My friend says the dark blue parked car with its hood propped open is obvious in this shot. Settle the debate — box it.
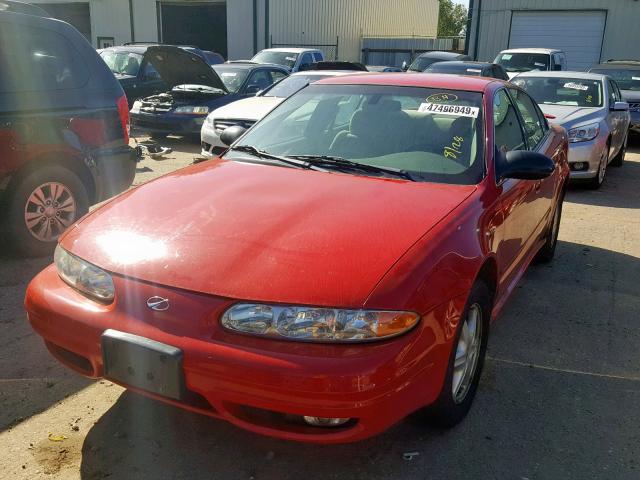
[131,46,289,141]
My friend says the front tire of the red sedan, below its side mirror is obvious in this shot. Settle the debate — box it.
[426,281,492,428]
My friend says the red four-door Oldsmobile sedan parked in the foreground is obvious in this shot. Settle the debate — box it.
[26,74,569,443]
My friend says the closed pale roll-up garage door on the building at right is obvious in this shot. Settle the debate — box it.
[509,10,607,71]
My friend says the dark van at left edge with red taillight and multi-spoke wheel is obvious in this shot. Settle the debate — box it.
[0,5,136,255]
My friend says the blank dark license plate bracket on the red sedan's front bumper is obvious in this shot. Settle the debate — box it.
[101,330,184,400]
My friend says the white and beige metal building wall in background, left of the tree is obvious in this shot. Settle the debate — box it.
[37,0,438,61]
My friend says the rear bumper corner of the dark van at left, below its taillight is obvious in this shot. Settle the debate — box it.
[92,145,137,203]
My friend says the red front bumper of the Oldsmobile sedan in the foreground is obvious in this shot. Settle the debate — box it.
[25,266,456,443]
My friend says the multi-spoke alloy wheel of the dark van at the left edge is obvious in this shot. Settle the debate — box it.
[24,182,77,242]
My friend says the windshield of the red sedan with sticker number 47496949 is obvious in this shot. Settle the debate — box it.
[225,84,484,185]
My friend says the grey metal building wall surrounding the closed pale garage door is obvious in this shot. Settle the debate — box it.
[469,0,640,61]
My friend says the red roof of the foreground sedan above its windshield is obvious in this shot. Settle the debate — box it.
[316,73,500,92]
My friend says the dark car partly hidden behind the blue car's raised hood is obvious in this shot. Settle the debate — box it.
[99,43,224,107]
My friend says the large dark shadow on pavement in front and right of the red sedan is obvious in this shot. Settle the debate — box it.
[81,242,640,480]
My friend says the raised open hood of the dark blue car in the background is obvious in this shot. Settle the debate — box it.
[144,45,228,92]
